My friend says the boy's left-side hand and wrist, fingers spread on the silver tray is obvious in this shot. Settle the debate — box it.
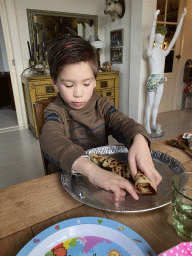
[73,157,139,201]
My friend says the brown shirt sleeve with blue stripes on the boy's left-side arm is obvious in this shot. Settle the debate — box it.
[39,105,86,172]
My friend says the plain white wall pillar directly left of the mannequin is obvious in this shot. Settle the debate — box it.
[129,0,156,123]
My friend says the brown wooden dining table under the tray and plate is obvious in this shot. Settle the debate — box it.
[0,135,192,256]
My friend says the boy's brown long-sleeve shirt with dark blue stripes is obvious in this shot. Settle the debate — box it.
[39,91,149,171]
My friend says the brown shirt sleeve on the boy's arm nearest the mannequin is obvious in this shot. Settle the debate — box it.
[100,98,151,149]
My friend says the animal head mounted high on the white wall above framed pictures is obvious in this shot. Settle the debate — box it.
[104,0,125,22]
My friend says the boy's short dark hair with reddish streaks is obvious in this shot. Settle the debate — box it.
[47,35,99,82]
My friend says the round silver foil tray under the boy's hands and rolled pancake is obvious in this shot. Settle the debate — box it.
[61,145,185,213]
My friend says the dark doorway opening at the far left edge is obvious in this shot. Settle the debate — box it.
[0,17,18,130]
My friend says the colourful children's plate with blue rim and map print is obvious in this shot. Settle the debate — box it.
[17,217,157,256]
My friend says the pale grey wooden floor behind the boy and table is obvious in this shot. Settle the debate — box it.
[0,108,192,189]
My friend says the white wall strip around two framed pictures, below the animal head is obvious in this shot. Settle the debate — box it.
[103,0,131,114]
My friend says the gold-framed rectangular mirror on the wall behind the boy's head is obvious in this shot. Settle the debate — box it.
[27,9,98,63]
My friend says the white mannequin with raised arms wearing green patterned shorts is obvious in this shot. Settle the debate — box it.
[145,8,187,134]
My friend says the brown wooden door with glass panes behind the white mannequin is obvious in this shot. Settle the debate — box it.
[157,0,183,112]
